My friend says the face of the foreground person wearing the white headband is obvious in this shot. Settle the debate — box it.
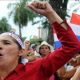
[0,35,20,66]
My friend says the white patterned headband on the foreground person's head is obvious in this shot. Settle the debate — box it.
[2,32,24,48]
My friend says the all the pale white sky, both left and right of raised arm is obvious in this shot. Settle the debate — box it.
[0,0,80,39]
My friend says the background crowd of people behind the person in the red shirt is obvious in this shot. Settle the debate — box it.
[22,39,80,80]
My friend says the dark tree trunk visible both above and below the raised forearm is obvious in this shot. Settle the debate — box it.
[36,0,68,45]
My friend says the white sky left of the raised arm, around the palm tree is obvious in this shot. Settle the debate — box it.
[0,0,40,39]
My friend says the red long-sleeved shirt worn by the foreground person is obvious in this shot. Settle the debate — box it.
[5,22,80,80]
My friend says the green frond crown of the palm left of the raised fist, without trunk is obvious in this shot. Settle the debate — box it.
[14,0,36,27]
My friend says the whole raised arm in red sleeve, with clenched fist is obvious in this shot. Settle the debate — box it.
[28,1,80,74]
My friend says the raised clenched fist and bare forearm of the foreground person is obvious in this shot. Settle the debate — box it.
[28,1,67,29]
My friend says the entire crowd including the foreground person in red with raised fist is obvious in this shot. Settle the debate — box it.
[0,1,80,80]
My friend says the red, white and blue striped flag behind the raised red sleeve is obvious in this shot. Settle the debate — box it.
[54,13,80,49]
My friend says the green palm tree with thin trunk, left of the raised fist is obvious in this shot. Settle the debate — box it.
[8,0,37,37]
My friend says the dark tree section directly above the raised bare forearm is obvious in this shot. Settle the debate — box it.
[49,0,68,19]
